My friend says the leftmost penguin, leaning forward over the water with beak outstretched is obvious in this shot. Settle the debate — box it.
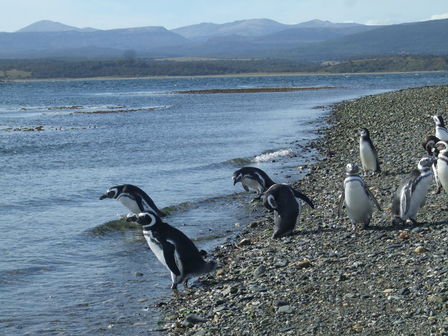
[100,184,166,217]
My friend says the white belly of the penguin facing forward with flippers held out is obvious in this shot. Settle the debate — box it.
[345,182,372,222]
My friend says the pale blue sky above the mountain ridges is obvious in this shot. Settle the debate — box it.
[0,0,448,32]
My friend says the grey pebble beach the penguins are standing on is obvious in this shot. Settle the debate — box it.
[159,86,448,336]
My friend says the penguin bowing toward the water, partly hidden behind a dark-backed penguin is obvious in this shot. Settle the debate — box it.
[232,167,275,200]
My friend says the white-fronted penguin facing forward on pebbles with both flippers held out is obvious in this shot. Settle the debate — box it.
[338,163,382,230]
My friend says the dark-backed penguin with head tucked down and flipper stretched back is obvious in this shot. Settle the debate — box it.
[263,184,314,238]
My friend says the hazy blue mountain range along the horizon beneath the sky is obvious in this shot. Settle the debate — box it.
[0,19,448,62]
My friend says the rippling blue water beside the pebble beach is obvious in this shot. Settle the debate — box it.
[0,73,448,335]
